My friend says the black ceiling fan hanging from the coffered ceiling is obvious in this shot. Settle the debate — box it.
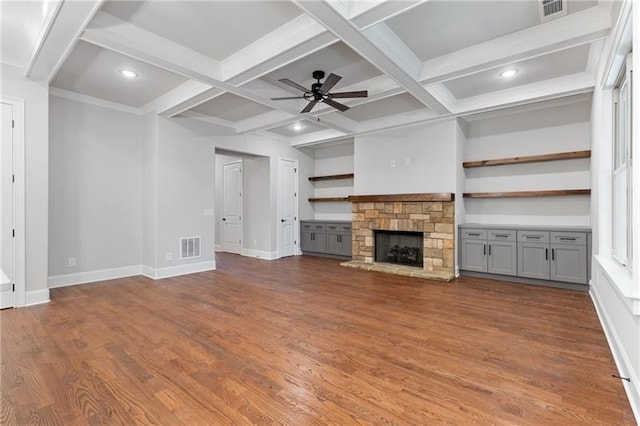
[271,71,368,112]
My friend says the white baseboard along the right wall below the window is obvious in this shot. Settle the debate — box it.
[589,286,640,423]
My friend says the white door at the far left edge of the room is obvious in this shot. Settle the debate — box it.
[0,103,15,309]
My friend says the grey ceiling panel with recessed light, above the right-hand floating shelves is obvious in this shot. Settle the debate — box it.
[444,45,589,99]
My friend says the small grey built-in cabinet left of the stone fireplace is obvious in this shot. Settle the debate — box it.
[300,220,351,259]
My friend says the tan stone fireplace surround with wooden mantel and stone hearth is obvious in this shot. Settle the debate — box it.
[342,193,455,281]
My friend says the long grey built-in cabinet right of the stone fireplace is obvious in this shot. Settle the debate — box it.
[459,225,591,284]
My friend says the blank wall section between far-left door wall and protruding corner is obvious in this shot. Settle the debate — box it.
[49,96,144,276]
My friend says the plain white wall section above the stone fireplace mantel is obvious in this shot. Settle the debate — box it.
[354,119,456,195]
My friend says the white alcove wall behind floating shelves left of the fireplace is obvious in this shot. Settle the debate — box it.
[312,139,354,221]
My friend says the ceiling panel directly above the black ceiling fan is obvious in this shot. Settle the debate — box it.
[262,42,382,96]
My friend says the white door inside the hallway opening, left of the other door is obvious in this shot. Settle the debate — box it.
[222,160,243,254]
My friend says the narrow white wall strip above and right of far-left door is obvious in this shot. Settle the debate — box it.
[0,64,49,305]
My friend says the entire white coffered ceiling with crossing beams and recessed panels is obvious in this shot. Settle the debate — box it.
[0,0,619,146]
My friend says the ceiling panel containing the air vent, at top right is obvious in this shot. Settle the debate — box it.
[387,0,597,61]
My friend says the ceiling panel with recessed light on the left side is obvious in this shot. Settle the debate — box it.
[51,41,186,107]
